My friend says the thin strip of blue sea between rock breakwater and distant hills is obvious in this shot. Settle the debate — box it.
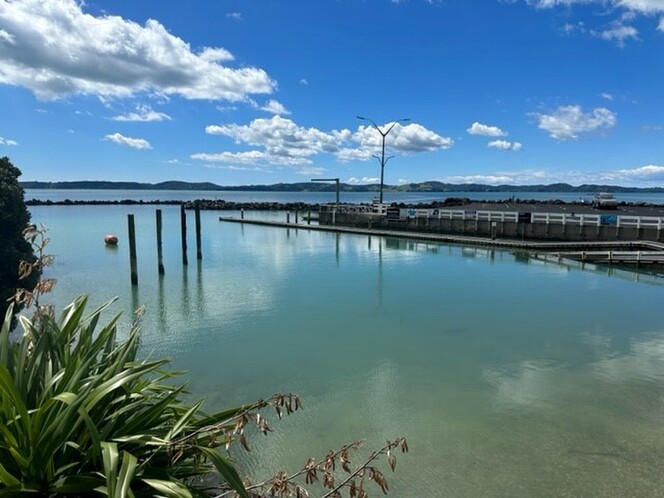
[25,189,664,204]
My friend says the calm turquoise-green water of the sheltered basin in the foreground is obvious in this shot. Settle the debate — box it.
[28,204,664,497]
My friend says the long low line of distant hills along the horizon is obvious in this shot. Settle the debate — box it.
[21,181,664,194]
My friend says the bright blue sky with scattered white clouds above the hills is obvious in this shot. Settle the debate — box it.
[0,0,664,187]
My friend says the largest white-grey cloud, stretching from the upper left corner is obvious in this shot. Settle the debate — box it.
[0,0,275,101]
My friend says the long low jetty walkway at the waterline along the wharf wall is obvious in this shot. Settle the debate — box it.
[219,216,664,266]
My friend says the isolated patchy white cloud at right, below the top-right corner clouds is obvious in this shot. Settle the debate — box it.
[535,105,616,140]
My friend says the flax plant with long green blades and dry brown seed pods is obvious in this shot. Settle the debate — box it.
[0,227,408,498]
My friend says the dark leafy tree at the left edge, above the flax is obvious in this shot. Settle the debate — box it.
[0,157,39,317]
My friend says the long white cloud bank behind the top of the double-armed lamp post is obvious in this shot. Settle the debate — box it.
[191,115,453,171]
